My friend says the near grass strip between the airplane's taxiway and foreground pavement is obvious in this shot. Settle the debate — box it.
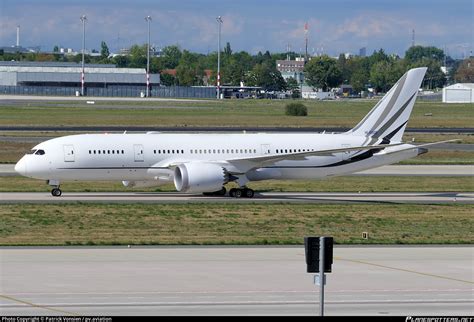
[0,202,474,245]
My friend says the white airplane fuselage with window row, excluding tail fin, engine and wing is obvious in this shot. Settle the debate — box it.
[17,133,418,184]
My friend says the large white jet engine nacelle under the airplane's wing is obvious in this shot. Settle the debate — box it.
[174,162,229,193]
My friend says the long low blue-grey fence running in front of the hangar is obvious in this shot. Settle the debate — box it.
[0,85,216,98]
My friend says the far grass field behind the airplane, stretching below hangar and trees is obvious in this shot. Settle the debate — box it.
[0,100,474,130]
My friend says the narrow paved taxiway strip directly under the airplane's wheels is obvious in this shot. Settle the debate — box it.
[0,191,474,204]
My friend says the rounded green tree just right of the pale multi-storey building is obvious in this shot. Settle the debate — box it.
[304,55,342,91]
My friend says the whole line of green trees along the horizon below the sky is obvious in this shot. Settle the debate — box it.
[0,41,474,93]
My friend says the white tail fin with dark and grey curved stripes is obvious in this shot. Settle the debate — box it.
[348,67,427,145]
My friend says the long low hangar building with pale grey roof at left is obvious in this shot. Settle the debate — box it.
[0,61,160,97]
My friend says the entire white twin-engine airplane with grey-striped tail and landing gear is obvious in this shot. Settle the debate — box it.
[15,67,448,198]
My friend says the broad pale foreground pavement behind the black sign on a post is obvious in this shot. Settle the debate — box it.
[0,247,474,316]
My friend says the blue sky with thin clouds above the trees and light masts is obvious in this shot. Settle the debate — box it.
[0,0,474,58]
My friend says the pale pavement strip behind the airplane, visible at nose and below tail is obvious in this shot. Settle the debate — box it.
[0,164,474,176]
